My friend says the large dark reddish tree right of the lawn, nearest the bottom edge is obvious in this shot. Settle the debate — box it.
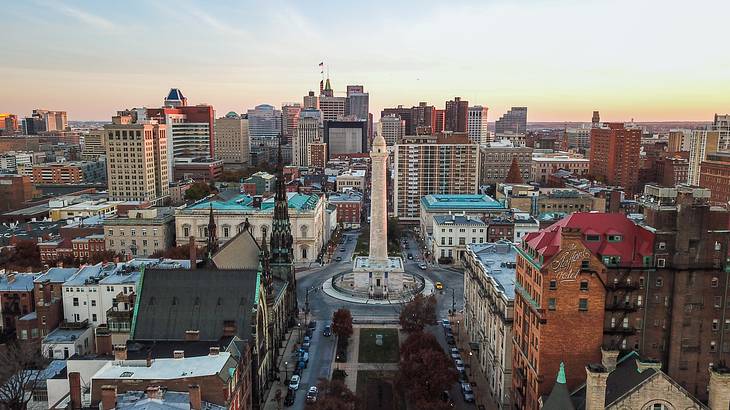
[396,332,457,408]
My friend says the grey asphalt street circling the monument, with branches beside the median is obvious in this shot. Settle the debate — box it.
[290,230,466,409]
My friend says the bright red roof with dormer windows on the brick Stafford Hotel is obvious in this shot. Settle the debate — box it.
[525,212,654,266]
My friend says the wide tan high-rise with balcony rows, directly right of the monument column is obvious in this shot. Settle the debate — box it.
[393,134,479,222]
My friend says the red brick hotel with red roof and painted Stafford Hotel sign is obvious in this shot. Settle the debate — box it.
[512,213,653,409]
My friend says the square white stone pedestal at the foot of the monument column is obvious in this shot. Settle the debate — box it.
[352,256,408,299]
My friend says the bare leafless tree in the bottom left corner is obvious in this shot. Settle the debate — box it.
[0,342,48,410]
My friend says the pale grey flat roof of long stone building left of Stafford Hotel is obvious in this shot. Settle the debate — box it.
[467,241,517,300]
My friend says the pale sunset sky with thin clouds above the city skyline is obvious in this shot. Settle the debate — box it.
[0,0,730,122]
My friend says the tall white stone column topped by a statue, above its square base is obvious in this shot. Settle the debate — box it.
[369,135,388,266]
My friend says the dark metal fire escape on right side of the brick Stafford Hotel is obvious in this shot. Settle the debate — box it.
[603,269,639,350]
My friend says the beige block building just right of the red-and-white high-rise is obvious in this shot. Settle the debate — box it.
[215,112,251,168]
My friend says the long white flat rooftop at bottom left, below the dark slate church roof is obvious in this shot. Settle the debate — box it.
[92,352,235,380]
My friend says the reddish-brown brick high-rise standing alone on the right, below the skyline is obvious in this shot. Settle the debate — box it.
[589,123,641,193]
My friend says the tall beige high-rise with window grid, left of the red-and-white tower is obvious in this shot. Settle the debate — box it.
[104,117,170,204]
